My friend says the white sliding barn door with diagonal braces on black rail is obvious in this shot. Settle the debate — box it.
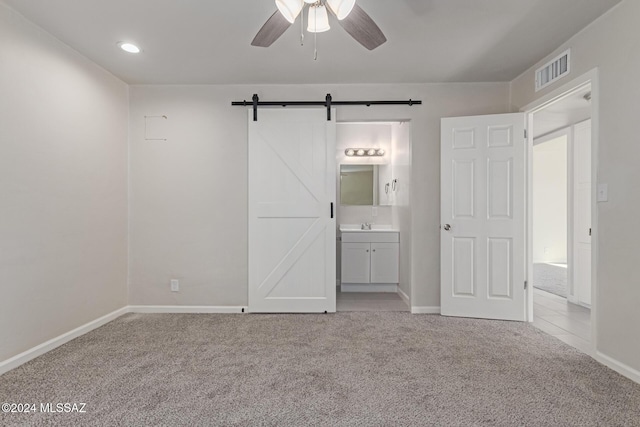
[248,108,336,313]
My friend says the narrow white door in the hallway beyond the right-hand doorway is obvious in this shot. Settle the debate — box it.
[573,120,591,306]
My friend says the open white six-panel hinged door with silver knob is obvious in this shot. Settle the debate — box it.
[440,113,525,321]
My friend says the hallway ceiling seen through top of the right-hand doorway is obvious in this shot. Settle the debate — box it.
[533,86,591,138]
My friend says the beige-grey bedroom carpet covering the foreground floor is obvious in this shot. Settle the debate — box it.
[0,312,640,426]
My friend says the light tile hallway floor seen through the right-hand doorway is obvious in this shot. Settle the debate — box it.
[533,289,591,354]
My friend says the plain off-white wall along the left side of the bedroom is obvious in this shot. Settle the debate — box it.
[0,3,128,361]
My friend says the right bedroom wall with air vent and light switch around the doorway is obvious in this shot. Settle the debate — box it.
[511,0,640,371]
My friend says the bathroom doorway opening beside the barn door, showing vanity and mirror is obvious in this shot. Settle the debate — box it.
[336,121,411,312]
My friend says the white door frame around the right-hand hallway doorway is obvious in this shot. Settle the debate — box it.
[520,68,600,356]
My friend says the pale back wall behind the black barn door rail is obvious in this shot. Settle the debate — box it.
[130,83,508,306]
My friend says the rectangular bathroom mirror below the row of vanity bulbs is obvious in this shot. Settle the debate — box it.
[340,165,391,206]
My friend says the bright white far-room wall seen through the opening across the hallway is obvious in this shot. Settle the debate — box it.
[533,135,568,263]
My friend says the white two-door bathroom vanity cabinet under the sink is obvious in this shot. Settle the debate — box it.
[340,230,400,292]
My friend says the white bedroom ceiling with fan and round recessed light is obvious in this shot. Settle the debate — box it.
[0,0,620,84]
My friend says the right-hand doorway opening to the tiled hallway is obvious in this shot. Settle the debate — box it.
[528,80,594,353]
